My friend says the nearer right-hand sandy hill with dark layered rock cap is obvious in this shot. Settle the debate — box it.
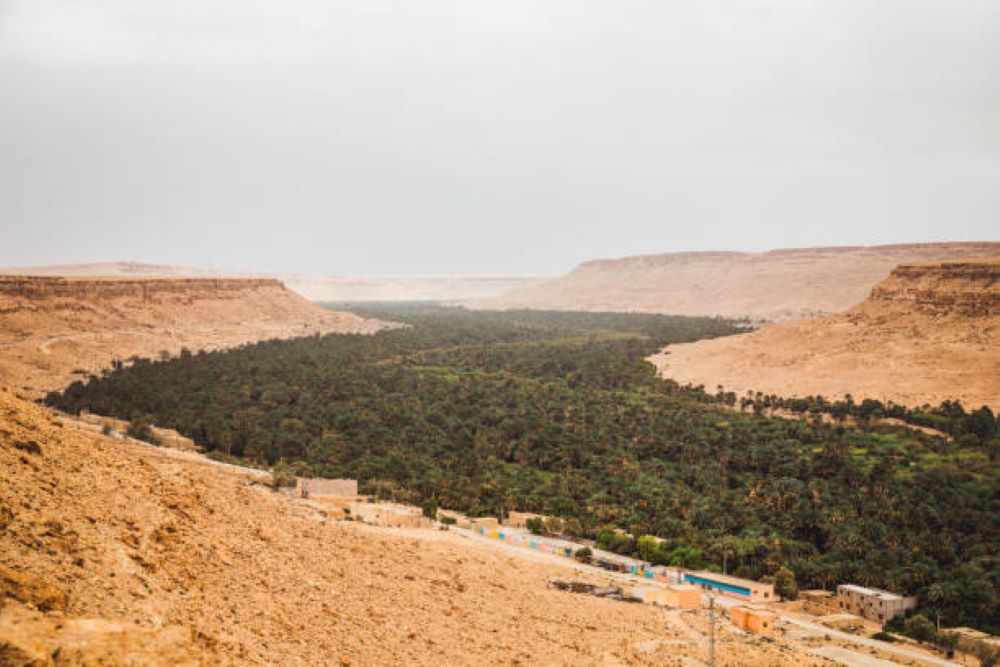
[651,259,1000,410]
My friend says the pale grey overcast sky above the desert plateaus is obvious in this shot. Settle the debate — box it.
[0,0,1000,274]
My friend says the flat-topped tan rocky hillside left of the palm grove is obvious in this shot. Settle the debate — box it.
[0,276,384,395]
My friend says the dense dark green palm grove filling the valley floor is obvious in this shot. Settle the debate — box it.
[48,306,1000,632]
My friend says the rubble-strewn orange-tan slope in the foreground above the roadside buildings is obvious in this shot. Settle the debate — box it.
[0,390,821,665]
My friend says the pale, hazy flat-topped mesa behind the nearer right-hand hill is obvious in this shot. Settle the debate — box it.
[470,243,1000,321]
